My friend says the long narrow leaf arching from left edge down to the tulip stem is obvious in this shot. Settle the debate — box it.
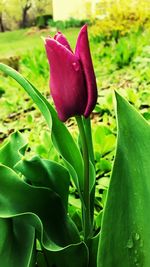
[0,63,83,196]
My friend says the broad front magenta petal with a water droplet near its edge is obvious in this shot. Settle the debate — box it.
[45,38,87,121]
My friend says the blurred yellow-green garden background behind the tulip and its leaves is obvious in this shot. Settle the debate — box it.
[0,0,150,222]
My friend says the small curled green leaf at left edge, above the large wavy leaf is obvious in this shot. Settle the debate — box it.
[0,132,27,168]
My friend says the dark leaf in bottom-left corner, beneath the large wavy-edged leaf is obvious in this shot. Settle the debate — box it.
[0,216,35,267]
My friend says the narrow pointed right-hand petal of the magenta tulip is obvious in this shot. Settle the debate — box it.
[75,25,97,117]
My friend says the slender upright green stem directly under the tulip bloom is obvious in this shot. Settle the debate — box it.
[76,116,91,242]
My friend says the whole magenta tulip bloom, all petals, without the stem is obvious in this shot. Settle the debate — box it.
[45,25,97,121]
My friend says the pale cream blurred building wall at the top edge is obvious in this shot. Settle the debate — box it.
[52,0,101,21]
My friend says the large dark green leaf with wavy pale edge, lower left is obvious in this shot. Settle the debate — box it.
[0,165,80,250]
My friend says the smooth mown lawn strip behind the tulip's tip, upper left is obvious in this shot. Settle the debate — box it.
[0,28,79,59]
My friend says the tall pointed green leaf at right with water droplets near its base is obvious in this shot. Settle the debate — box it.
[97,93,150,267]
